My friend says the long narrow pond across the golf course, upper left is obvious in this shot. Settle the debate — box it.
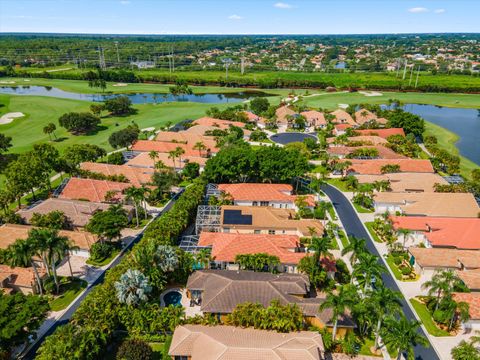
[0,85,272,104]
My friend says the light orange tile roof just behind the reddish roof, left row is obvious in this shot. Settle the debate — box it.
[80,162,153,187]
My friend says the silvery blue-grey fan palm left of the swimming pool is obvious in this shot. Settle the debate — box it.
[114,269,152,305]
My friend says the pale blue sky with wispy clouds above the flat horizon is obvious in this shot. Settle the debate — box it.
[0,0,480,34]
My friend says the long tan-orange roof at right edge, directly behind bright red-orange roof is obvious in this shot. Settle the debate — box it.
[374,192,480,218]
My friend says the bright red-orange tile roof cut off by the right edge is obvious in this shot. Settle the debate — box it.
[391,216,480,250]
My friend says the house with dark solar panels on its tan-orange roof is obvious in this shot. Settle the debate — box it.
[219,205,324,237]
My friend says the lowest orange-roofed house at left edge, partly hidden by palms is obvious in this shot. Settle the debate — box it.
[0,264,47,295]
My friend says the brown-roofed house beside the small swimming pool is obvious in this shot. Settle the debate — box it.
[187,270,355,337]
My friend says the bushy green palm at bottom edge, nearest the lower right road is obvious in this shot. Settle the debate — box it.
[382,315,429,360]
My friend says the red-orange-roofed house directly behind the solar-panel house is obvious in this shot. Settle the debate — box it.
[218,183,316,210]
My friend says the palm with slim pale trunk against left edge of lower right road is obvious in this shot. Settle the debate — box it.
[369,285,402,349]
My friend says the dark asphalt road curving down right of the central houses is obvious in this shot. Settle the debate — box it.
[322,185,440,360]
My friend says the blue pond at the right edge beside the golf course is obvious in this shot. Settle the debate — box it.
[403,104,480,165]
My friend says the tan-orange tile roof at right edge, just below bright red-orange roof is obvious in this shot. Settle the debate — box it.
[408,247,480,269]
